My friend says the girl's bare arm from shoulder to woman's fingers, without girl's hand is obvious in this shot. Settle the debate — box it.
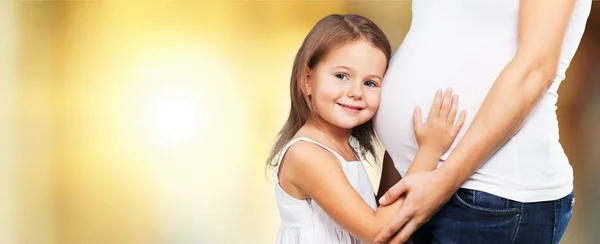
[282,141,418,243]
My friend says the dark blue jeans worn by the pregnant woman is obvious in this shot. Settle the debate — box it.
[412,189,575,244]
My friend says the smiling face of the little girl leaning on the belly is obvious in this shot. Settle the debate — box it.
[305,41,387,129]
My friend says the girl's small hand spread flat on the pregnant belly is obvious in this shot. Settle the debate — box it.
[413,89,466,154]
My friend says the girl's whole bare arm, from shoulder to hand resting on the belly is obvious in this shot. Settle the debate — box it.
[283,92,464,243]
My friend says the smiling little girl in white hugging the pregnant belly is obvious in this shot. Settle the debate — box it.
[267,15,465,244]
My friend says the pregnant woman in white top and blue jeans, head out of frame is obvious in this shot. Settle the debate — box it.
[375,0,591,243]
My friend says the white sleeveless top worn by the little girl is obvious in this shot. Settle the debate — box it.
[273,137,377,244]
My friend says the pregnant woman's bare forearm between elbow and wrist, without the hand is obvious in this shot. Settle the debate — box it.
[439,57,556,189]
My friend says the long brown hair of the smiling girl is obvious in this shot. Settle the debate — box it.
[267,14,392,166]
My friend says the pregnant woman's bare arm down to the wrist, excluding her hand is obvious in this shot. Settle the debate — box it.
[440,0,576,189]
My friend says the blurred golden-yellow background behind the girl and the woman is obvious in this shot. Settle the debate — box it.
[0,1,600,244]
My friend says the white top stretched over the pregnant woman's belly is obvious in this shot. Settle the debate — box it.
[374,0,592,202]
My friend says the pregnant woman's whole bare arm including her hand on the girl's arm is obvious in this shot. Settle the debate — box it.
[377,0,588,243]
